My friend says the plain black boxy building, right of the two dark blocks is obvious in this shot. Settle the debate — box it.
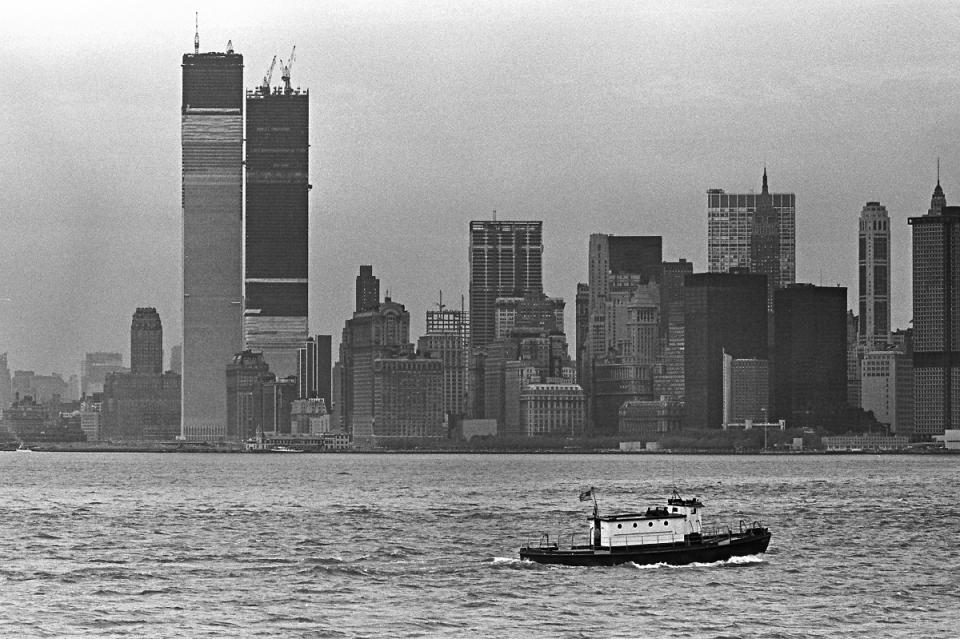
[773,284,847,428]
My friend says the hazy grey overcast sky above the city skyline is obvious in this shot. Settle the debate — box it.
[0,0,960,376]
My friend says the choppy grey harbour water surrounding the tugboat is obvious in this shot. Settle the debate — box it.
[0,452,960,637]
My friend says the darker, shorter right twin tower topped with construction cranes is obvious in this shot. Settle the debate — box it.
[243,65,310,379]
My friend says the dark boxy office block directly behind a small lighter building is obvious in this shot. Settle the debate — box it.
[684,273,767,428]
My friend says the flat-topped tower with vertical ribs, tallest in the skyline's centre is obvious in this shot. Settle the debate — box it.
[470,220,543,349]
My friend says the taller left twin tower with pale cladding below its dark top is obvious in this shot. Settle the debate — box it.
[181,33,243,439]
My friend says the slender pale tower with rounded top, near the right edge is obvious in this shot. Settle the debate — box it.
[858,202,891,349]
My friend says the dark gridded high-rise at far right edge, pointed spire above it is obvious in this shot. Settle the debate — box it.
[908,179,960,438]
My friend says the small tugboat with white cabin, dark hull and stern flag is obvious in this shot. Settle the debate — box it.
[520,487,770,566]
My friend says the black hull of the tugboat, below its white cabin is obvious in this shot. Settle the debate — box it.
[520,528,770,566]
